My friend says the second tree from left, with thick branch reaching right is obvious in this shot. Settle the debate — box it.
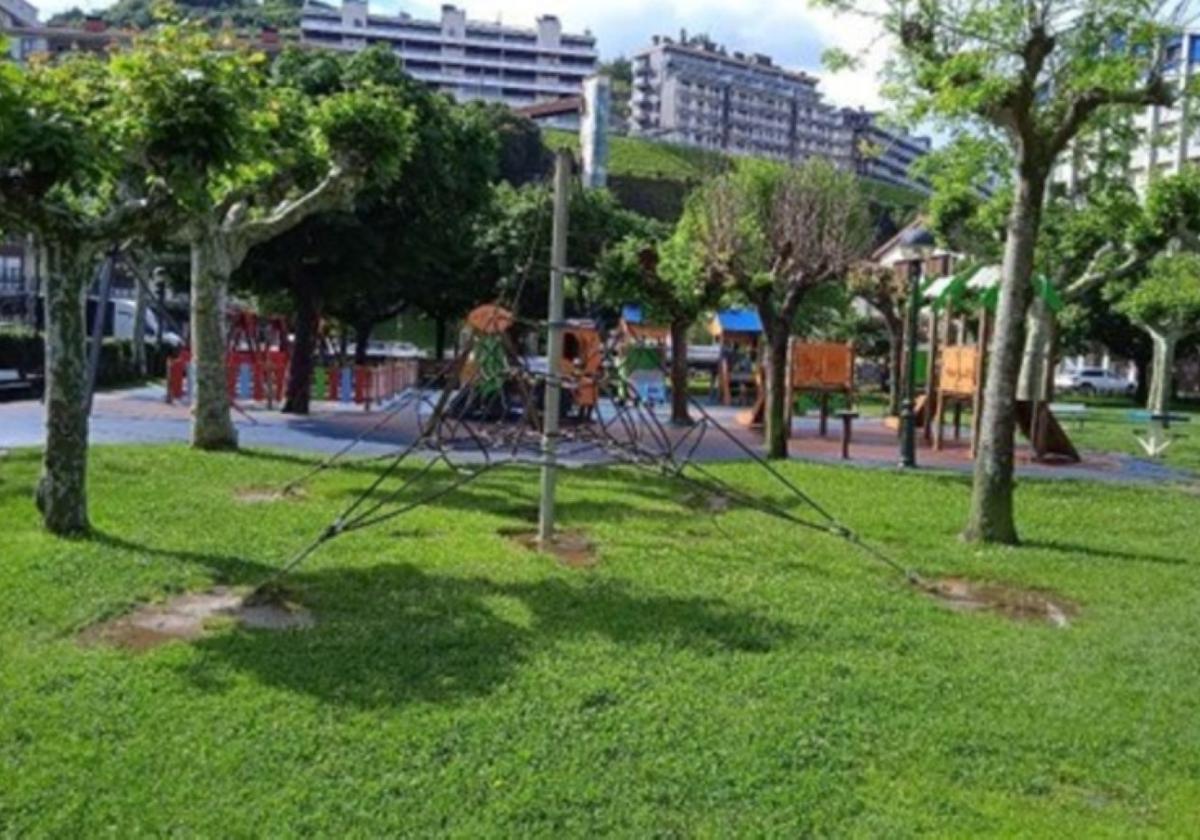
[113,24,412,449]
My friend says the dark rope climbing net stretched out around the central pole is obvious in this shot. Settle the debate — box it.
[259,296,925,590]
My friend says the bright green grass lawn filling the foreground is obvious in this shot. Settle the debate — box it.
[0,448,1200,838]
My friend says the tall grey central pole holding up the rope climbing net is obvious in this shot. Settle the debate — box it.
[538,149,571,542]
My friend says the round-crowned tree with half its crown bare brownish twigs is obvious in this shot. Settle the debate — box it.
[696,160,871,458]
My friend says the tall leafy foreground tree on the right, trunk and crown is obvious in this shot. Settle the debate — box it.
[815,0,1186,544]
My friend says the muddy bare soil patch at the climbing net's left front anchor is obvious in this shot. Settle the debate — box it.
[79,587,316,653]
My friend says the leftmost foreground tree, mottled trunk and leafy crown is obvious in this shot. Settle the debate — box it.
[0,44,157,535]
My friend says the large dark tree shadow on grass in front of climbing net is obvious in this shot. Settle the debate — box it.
[185,564,792,708]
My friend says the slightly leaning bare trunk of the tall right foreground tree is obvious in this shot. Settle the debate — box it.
[962,167,1045,545]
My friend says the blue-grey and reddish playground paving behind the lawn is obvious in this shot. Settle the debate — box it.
[0,386,1196,484]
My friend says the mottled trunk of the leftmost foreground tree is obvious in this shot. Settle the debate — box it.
[37,247,91,536]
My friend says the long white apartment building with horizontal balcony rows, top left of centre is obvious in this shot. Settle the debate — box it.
[300,0,599,107]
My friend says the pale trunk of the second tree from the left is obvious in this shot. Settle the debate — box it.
[192,240,238,450]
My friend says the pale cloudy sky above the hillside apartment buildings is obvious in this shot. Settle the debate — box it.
[34,0,887,109]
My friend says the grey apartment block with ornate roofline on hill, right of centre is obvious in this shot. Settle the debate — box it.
[630,32,851,168]
